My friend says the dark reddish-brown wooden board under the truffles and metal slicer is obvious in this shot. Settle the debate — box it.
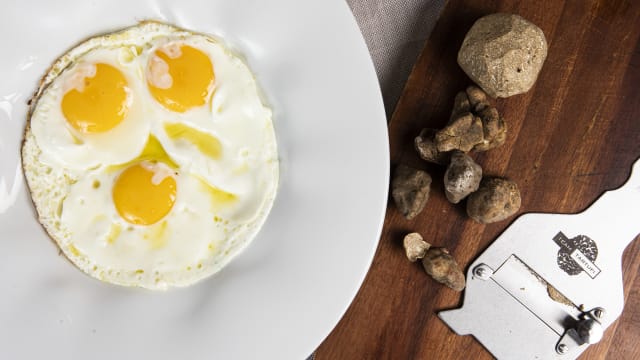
[316,0,640,360]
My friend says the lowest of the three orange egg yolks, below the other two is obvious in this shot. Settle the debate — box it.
[113,163,176,225]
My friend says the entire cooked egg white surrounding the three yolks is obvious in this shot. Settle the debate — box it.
[22,22,278,289]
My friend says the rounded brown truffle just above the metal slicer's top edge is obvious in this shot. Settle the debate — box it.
[467,178,521,224]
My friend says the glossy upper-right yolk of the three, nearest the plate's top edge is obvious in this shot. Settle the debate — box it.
[147,43,214,112]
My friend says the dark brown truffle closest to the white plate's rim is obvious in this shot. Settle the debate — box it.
[391,165,431,220]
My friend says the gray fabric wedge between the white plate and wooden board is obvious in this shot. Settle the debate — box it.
[347,0,445,118]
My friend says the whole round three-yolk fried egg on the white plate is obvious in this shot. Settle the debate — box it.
[22,22,278,289]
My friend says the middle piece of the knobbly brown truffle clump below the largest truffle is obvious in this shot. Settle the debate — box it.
[435,112,484,152]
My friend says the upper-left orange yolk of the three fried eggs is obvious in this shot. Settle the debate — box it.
[61,63,129,134]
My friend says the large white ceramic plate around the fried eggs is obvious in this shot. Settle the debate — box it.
[0,0,389,359]
